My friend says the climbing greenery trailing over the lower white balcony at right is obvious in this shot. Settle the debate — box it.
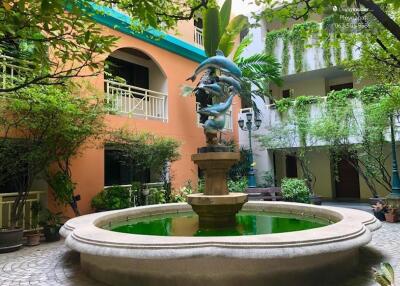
[259,85,400,196]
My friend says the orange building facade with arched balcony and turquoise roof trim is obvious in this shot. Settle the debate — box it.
[0,3,240,221]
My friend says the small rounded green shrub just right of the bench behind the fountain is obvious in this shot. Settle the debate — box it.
[281,178,310,203]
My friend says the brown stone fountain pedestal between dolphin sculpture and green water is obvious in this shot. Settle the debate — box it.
[188,152,247,229]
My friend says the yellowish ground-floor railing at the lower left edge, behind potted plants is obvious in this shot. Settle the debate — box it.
[0,191,47,230]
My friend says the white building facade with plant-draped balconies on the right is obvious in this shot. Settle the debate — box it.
[239,16,398,200]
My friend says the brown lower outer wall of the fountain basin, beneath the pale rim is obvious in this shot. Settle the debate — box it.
[81,249,359,286]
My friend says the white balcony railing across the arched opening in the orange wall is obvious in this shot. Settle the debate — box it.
[105,80,168,121]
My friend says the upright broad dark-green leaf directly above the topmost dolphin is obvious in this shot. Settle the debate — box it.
[203,8,221,57]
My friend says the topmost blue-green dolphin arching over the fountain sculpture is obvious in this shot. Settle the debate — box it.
[186,51,242,82]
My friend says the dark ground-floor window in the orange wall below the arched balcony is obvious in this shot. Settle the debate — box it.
[104,147,150,186]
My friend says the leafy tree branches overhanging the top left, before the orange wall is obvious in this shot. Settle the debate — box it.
[0,0,214,93]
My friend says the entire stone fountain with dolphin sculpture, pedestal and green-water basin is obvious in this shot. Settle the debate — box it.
[60,53,380,286]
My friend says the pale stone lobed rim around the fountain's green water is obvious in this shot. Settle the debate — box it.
[60,202,381,259]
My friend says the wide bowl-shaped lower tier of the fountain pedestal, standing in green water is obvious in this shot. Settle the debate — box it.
[188,193,247,229]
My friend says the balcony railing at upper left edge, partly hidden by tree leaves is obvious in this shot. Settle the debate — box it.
[0,54,31,89]
